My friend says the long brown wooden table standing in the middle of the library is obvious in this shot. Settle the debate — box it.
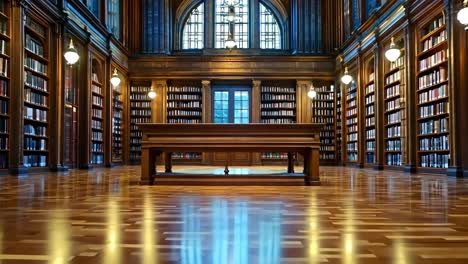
[138,124,321,185]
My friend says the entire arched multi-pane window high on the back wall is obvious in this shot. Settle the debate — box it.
[178,0,284,49]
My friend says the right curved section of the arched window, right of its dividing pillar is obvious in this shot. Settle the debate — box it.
[260,3,281,49]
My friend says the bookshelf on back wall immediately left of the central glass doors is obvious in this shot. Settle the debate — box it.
[166,81,203,163]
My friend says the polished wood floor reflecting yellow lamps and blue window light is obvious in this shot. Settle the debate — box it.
[0,167,468,264]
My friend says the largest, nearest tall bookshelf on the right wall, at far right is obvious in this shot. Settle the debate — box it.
[416,15,450,168]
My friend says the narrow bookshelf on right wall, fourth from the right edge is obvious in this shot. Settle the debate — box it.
[345,81,359,162]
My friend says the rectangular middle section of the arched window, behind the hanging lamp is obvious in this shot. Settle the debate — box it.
[215,0,249,49]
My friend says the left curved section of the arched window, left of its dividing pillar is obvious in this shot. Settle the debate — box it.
[182,3,205,49]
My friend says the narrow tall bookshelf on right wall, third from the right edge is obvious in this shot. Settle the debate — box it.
[364,65,376,164]
